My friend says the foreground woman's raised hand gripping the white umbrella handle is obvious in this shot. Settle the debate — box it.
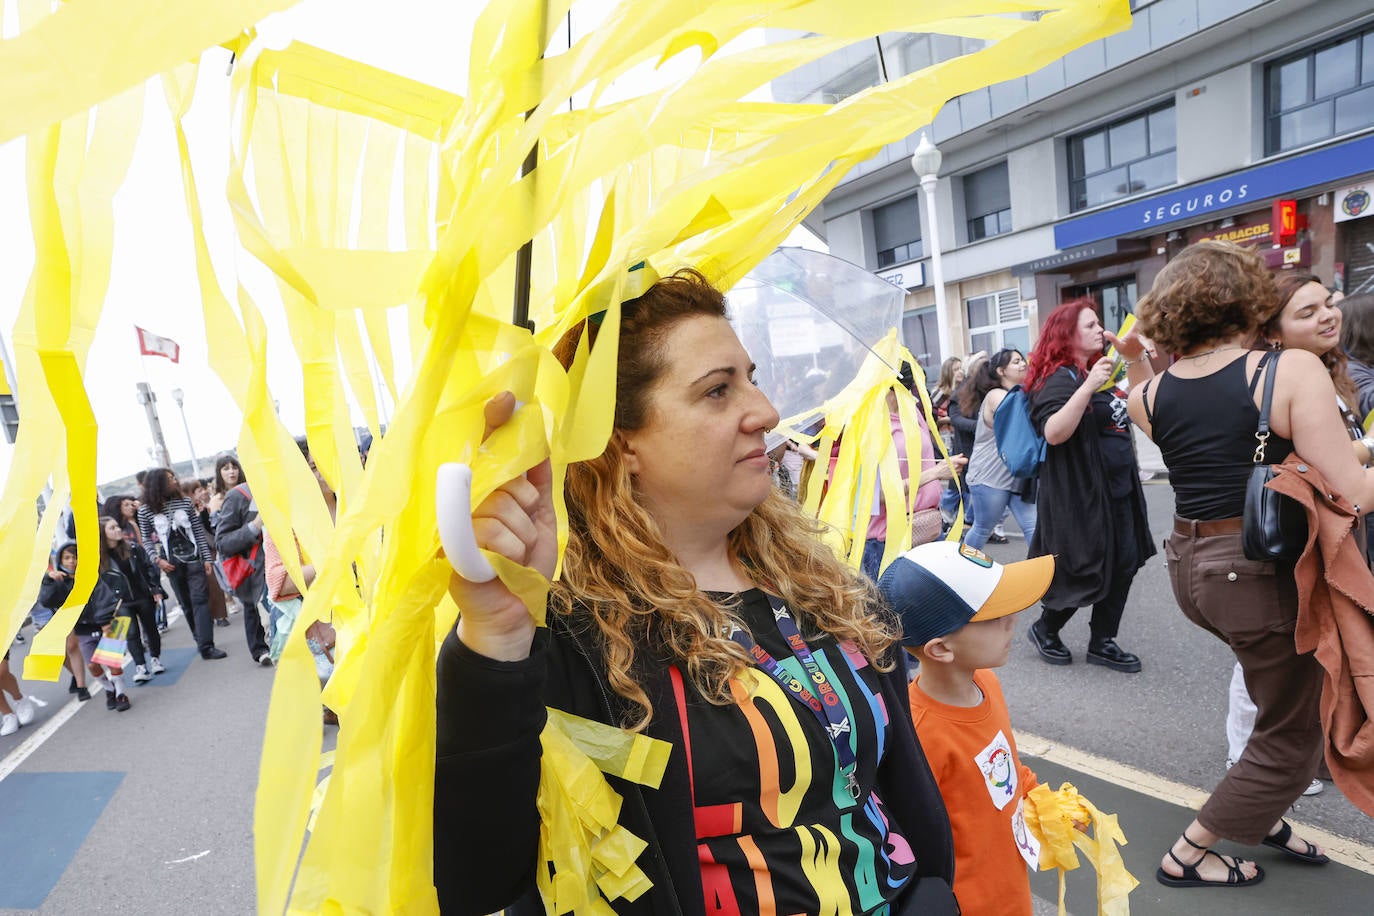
[448,391,558,662]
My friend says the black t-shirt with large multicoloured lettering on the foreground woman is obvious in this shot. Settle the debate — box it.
[681,589,916,916]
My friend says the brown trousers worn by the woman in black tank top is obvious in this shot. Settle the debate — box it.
[1164,522,1323,846]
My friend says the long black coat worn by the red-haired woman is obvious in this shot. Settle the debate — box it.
[1029,368,1156,608]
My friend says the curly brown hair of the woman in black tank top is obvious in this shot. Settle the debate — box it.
[1135,239,1281,353]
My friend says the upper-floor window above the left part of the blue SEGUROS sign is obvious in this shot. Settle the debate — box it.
[1069,102,1179,210]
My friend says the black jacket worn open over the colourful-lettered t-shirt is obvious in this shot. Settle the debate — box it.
[434,612,954,915]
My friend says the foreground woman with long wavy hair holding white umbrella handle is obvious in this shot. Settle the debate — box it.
[434,271,955,913]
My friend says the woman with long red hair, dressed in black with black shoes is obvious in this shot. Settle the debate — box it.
[1026,299,1154,672]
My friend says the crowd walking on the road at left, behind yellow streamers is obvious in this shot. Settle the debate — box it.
[0,437,338,735]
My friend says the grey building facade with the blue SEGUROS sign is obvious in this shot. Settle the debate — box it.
[774,0,1374,372]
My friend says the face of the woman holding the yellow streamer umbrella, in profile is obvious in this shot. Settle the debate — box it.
[621,316,778,540]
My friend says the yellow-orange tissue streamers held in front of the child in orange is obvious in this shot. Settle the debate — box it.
[1024,783,1140,916]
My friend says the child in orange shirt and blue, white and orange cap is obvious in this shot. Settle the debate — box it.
[878,541,1054,916]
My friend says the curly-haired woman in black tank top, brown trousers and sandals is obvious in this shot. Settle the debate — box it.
[1129,242,1374,887]
